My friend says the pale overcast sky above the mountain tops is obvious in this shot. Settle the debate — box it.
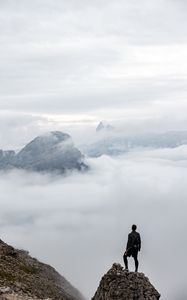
[0,0,187,147]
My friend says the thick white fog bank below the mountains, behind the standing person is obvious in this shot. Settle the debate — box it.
[0,146,187,300]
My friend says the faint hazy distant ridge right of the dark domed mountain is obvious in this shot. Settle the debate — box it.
[80,127,187,157]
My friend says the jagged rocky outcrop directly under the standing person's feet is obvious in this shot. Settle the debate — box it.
[92,264,160,300]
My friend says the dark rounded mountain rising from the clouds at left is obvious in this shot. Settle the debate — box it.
[0,131,87,173]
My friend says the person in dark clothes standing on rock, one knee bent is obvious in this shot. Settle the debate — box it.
[123,225,141,272]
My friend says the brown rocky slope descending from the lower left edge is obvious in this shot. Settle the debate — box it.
[0,240,84,300]
